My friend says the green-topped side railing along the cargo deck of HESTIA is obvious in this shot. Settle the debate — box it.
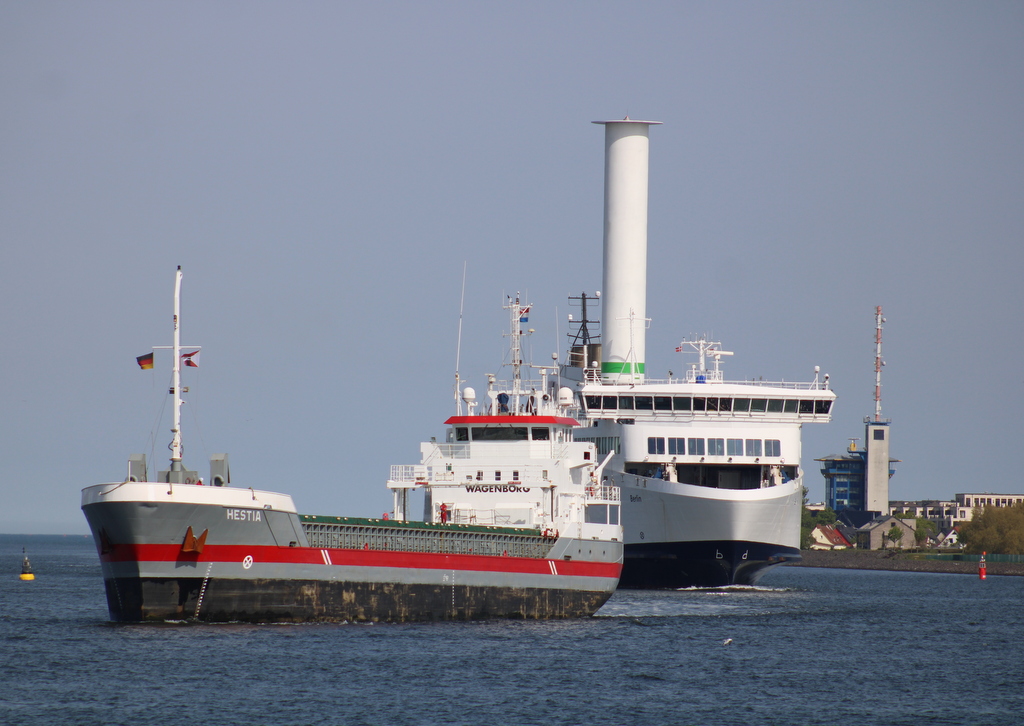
[302,522,554,559]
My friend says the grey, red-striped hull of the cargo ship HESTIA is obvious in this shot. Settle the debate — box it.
[83,483,623,623]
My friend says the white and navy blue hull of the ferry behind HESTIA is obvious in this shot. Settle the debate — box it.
[617,475,803,589]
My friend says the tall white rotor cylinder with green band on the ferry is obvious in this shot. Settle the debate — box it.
[594,117,662,383]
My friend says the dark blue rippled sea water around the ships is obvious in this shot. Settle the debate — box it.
[0,536,1024,726]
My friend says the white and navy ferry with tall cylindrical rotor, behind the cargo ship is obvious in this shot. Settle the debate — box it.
[560,118,836,589]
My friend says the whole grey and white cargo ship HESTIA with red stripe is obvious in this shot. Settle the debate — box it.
[82,267,624,623]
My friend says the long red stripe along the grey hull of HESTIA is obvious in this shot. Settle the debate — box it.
[100,545,622,578]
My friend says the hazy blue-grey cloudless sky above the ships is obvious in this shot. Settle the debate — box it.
[0,0,1024,532]
